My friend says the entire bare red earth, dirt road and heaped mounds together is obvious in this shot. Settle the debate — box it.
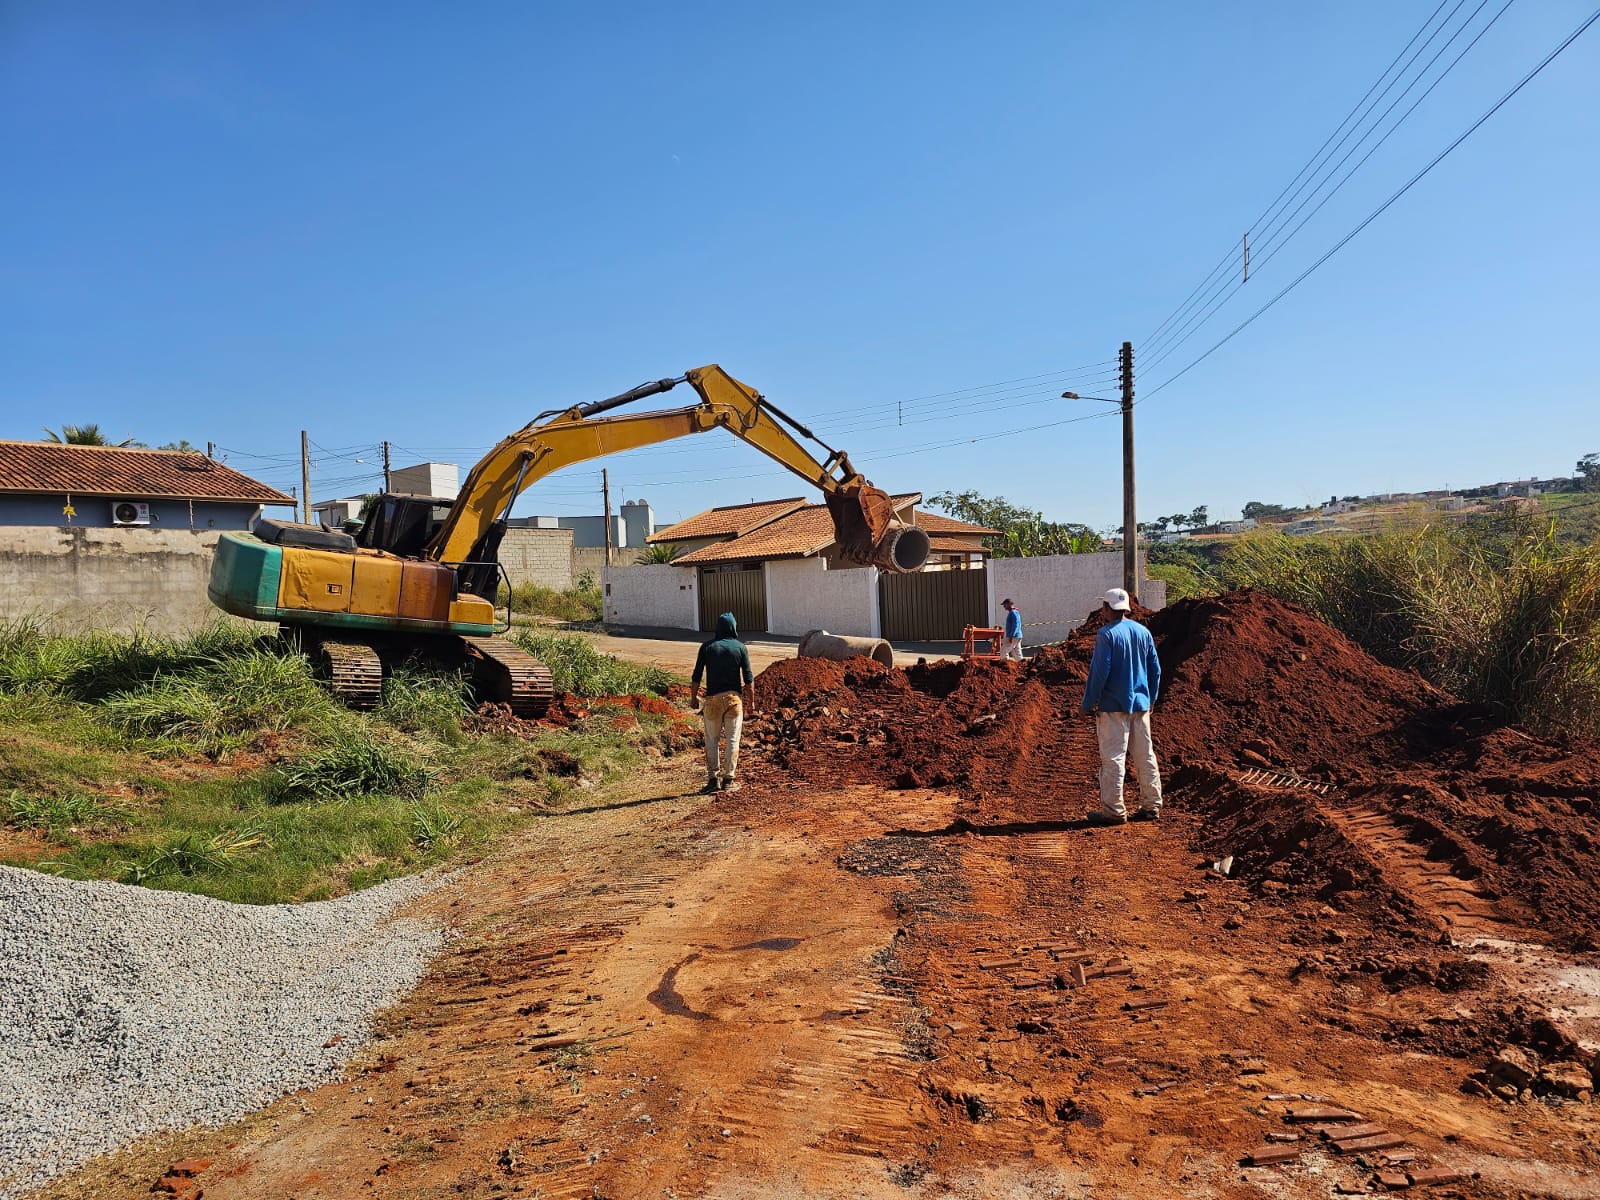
[40,597,1600,1200]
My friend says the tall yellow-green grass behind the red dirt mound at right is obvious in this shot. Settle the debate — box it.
[1222,514,1600,736]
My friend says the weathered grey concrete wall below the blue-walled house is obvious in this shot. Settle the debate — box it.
[0,525,234,637]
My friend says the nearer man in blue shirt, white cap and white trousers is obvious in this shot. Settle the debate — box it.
[1082,587,1162,826]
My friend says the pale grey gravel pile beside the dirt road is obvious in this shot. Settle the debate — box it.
[0,867,446,1200]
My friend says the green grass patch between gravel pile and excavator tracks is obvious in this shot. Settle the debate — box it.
[0,621,670,904]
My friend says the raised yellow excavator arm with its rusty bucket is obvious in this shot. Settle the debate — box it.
[426,365,928,571]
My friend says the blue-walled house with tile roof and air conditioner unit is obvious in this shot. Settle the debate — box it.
[0,442,294,530]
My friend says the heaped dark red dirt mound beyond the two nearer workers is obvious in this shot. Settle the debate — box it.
[747,592,1600,946]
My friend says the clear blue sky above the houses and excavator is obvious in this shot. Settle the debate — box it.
[0,0,1600,526]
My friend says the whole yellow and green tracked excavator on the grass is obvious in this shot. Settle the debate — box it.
[206,365,930,717]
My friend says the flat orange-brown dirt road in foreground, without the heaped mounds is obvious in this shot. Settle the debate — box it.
[43,764,1600,1200]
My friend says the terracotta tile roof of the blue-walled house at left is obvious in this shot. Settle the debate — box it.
[0,442,294,504]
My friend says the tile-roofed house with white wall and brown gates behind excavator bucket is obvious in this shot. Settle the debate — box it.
[606,493,995,640]
